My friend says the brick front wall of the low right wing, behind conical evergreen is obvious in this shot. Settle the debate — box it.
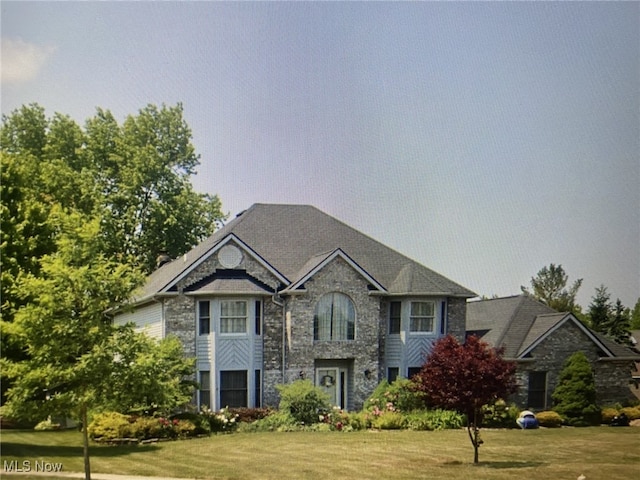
[512,322,633,409]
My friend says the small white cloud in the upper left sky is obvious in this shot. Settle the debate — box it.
[0,38,56,84]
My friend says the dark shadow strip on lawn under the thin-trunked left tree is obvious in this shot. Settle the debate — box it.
[2,442,158,458]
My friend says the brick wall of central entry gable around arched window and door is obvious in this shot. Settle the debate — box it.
[284,258,380,409]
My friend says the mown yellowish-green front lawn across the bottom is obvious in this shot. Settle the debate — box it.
[0,427,640,480]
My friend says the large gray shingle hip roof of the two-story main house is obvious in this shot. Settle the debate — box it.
[138,203,476,299]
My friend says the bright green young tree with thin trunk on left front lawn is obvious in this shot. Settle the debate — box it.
[2,212,191,479]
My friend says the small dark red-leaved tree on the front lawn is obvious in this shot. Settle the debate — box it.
[414,335,517,463]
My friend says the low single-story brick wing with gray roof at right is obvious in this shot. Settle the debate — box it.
[467,295,640,411]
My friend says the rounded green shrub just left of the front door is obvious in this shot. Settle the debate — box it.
[278,380,331,425]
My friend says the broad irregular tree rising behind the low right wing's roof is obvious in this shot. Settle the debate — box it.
[520,263,582,314]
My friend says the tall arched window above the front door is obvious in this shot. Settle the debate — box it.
[313,293,356,341]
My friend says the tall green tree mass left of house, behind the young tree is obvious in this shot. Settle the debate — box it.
[0,104,225,399]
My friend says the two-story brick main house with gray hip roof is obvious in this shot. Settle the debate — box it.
[114,204,476,410]
